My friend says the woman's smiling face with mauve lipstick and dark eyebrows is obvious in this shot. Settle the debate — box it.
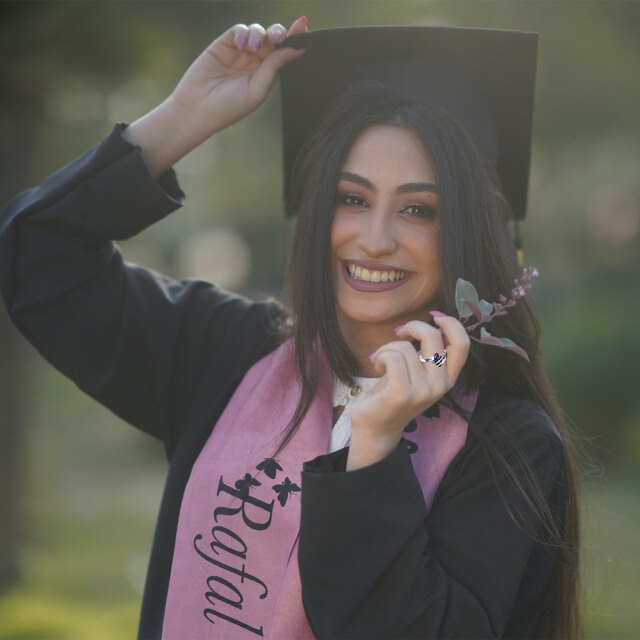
[331,125,440,329]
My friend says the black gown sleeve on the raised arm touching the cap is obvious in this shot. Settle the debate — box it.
[0,123,273,453]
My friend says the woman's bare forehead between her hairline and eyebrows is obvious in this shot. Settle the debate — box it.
[343,125,434,182]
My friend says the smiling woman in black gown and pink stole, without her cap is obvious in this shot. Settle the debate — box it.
[0,18,579,638]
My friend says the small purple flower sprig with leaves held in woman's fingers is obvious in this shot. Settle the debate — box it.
[456,267,539,362]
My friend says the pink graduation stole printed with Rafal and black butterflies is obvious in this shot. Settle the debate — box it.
[162,340,478,640]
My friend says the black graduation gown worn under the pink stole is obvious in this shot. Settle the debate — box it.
[0,123,566,638]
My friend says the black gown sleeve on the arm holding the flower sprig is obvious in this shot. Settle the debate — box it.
[298,401,565,639]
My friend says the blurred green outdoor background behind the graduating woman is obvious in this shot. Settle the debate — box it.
[0,0,640,638]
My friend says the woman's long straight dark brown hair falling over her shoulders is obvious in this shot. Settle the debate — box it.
[262,80,583,639]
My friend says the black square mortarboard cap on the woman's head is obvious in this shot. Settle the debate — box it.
[276,26,538,220]
